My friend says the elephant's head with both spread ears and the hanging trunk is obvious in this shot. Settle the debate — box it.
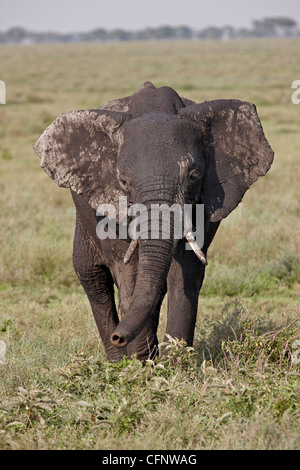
[34,82,273,346]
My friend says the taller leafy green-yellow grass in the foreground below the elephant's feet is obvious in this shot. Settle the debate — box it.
[0,304,300,450]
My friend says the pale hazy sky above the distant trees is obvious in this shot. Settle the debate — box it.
[0,0,300,32]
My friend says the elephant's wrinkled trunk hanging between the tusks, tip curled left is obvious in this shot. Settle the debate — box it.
[111,182,176,347]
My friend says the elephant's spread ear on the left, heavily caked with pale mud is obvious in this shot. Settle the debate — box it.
[33,109,129,209]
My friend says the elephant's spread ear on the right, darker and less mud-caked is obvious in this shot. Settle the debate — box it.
[179,100,274,222]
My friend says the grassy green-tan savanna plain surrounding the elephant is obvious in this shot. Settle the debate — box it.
[0,39,300,450]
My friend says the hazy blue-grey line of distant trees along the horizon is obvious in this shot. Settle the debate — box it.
[0,17,300,44]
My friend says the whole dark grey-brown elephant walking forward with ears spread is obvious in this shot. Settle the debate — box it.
[33,82,274,361]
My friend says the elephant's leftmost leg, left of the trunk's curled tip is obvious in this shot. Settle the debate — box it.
[73,217,126,361]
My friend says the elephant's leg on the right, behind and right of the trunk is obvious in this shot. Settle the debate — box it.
[165,240,205,346]
